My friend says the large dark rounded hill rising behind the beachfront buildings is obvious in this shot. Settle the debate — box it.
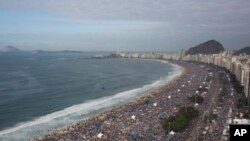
[187,40,225,55]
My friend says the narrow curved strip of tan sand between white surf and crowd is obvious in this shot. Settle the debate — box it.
[32,59,186,140]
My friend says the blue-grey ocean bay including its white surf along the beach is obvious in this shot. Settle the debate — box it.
[0,52,181,140]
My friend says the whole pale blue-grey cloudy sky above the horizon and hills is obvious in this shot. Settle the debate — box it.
[0,0,250,51]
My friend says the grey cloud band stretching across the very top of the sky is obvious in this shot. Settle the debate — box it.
[0,0,250,22]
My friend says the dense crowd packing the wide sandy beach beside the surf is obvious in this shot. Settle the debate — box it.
[34,61,234,141]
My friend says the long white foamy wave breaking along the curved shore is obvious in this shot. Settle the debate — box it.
[0,61,181,140]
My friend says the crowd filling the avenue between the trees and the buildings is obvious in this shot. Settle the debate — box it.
[172,64,241,141]
